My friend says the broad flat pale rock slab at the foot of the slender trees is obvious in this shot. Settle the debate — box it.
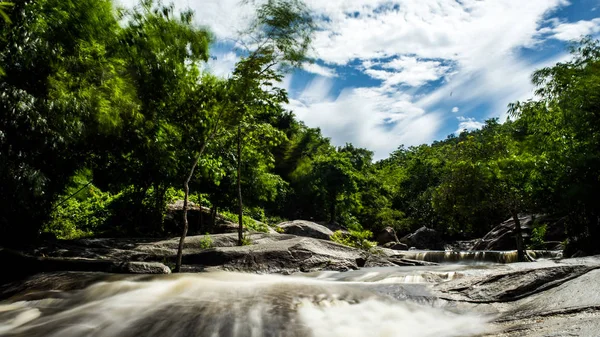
[183,237,365,274]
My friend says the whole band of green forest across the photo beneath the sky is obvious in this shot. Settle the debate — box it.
[0,0,600,253]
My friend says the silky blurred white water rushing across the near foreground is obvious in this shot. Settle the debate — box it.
[0,268,487,337]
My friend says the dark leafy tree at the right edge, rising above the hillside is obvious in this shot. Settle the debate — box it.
[509,38,600,253]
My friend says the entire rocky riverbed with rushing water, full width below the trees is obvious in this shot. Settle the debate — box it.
[0,233,600,337]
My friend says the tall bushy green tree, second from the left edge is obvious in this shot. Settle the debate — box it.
[105,0,214,236]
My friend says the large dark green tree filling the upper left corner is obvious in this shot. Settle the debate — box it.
[0,0,136,244]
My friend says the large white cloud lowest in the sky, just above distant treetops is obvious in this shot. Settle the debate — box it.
[289,78,441,159]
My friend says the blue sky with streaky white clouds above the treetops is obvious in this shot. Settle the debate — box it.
[121,0,600,159]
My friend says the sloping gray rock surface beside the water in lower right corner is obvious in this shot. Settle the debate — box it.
[431,256,600,337]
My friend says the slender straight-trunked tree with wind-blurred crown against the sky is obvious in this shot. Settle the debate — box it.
[227,0,314,245]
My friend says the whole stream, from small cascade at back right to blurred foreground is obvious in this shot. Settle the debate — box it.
[0,248,568,337]
